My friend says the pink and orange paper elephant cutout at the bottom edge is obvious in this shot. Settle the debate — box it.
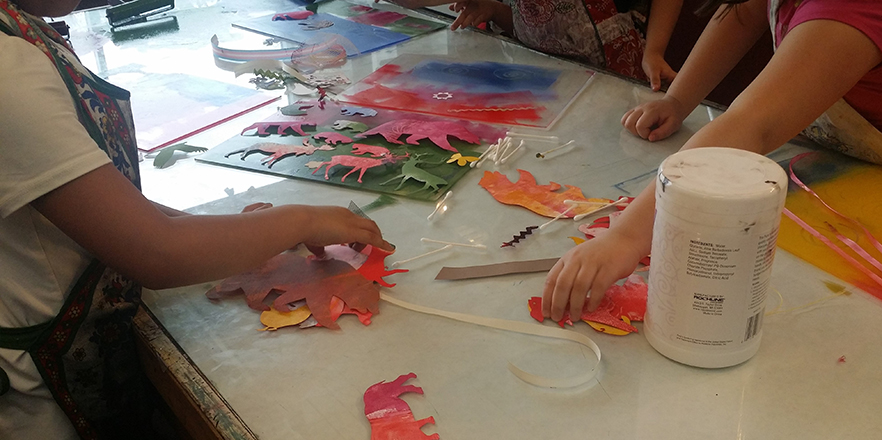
[364,373,441,440]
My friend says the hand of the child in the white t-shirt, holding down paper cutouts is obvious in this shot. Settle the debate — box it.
[295,206,393,251]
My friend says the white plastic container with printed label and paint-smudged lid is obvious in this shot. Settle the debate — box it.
[644,148,787,368]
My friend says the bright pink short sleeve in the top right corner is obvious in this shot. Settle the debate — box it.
[789,0,882,50]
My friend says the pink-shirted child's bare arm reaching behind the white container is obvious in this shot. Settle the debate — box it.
[542,9,882,320]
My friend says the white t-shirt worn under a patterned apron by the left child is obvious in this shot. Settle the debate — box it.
[0,33,110,439]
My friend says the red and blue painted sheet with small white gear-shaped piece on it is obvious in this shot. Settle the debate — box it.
[339,55,593,128]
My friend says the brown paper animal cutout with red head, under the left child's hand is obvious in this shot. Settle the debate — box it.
[206,246,406,329]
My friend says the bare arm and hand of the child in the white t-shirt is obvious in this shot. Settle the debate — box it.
[32,164,390,288]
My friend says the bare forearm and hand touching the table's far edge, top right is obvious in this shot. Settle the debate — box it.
[642,0,683,91]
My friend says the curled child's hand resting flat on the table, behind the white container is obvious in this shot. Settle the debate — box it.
[622,96,689,142]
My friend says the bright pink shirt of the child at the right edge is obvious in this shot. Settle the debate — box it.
[775,0,882,130]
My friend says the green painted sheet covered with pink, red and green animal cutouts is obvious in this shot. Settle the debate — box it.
[199,101,504,200]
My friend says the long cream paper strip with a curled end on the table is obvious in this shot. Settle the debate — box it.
[380,292,600,388]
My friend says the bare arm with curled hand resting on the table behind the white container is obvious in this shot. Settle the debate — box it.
[622,0,769,141]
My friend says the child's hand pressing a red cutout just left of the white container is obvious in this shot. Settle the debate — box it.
[542,229,643,322]
